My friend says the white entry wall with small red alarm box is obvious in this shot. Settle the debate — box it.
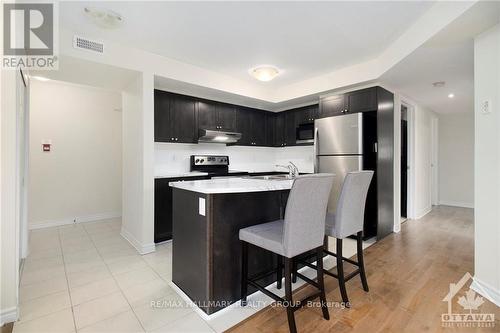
[28,80,122,228]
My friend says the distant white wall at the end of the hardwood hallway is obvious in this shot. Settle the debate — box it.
[439,112,474,208]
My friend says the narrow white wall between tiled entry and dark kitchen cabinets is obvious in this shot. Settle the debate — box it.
[121,73,155,254]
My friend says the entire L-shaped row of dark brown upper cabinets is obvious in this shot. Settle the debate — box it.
[154,87,379,147]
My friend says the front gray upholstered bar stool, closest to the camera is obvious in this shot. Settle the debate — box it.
[239,174,334,333]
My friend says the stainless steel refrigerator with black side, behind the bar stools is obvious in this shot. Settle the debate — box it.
[314,112,377,238]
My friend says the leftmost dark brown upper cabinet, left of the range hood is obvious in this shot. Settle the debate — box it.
[154,90,198,143]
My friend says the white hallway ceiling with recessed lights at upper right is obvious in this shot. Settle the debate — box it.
[381,2,500,114]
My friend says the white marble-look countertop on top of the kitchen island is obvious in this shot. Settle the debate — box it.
[170,177,293,194]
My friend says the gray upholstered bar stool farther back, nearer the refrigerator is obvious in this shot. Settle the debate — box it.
[324,171,373,307]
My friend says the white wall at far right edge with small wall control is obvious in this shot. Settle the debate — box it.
[472,25,500,306]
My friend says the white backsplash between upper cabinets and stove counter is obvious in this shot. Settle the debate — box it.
[155,143,313,174]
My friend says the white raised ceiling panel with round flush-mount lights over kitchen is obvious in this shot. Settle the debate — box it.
[59,1,433,89]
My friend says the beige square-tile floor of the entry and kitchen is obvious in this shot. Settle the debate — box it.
[14,219,374,333]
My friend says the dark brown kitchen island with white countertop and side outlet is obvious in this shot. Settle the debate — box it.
[170,178,293,315]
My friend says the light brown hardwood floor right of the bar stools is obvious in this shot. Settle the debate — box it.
[229,206,500,333]
